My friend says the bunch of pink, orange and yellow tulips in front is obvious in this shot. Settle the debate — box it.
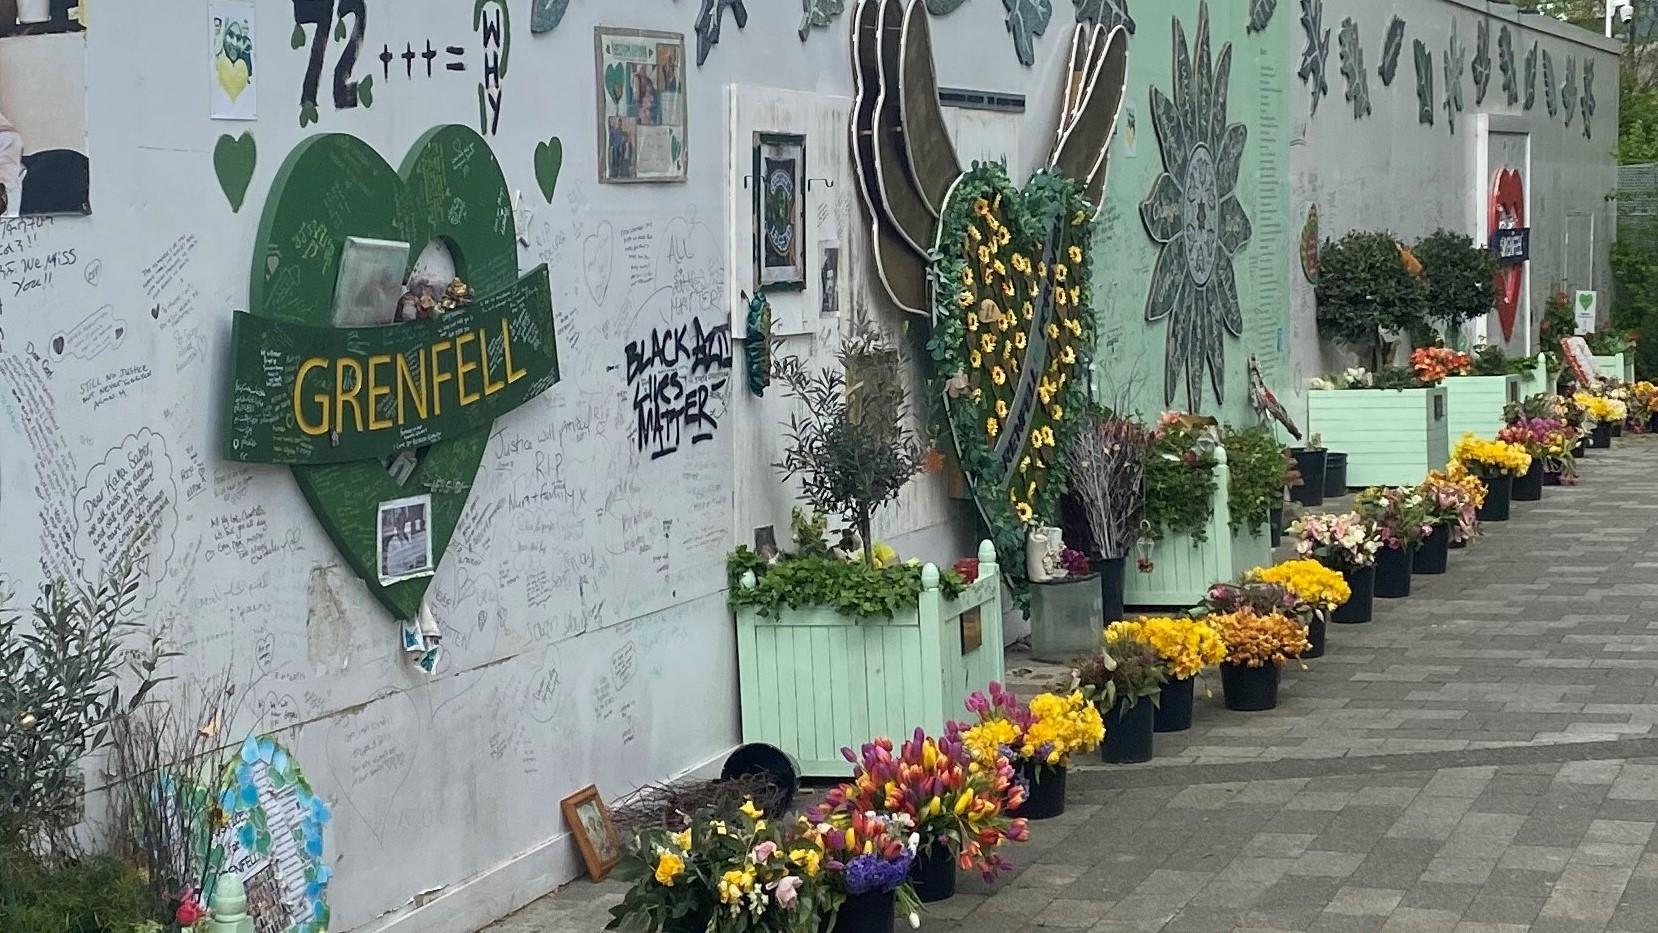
[809,729,1028,882]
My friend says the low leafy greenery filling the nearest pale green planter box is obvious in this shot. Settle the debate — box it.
[726,547,967,618]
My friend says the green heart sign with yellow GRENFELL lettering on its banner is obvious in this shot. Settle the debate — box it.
[222,126,559,620]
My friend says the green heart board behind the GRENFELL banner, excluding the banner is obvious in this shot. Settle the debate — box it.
[242,126,557,620]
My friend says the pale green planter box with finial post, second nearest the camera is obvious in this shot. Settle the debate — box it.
[1122,447,1272,608]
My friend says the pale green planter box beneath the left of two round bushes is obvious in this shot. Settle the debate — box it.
[1307,386,1451,487]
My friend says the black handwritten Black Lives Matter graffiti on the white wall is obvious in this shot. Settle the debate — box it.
[627,318,731,461]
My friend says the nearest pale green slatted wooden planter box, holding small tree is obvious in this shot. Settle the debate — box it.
[736,540,1001,777]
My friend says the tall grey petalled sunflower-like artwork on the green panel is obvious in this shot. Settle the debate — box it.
[1141,0,1246,411]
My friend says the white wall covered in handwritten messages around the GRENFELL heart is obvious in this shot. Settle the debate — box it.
[0,0,1069,933]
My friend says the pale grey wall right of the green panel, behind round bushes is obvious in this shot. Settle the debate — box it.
[1290,0,1620,411]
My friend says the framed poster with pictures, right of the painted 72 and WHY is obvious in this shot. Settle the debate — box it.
[594,27,688,184]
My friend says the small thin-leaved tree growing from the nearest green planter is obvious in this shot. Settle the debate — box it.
[776,318,922,567]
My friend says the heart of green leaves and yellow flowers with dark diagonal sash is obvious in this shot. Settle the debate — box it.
[930,164,1094,572]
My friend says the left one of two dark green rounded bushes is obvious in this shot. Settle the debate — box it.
[1318,230,1428,370]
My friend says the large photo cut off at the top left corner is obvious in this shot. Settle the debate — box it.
[0,0,91,217]
